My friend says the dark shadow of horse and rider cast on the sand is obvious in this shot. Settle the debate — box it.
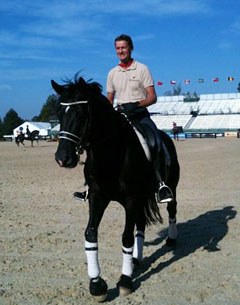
[108,206,237,301]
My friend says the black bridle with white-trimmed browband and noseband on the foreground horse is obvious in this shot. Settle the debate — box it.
[59,100,90,153]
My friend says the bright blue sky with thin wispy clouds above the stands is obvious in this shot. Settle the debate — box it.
[0,0,240,119]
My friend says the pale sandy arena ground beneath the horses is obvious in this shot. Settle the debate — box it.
[0,138,240,305]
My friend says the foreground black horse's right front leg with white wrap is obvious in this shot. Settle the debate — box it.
[117,204,136,296]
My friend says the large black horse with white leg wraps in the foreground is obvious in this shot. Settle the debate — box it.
[51,76,179,301]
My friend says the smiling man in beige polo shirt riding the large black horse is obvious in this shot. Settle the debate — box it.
[74,34,173,202]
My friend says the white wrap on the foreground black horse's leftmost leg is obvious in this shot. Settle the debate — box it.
[85,241,100,279]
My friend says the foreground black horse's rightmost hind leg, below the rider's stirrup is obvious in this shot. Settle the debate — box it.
[166,199,178,247]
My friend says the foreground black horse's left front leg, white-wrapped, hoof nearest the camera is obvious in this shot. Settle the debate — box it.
[85,194,109,302]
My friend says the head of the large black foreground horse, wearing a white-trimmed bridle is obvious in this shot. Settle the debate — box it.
[51,78,95,168]
